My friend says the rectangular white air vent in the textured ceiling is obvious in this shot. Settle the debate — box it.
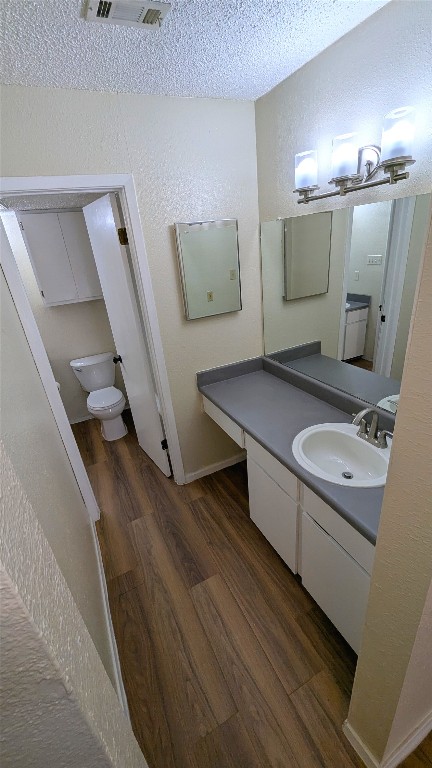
[86,0,171,29]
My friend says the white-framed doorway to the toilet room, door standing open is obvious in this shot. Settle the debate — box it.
[0,175,184,520]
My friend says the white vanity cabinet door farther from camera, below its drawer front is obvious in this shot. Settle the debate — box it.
[247,456,297,573]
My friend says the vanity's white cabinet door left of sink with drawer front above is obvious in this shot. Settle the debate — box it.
[245,435,298,573]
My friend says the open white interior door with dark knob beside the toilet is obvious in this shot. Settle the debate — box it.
[83,194,171,476]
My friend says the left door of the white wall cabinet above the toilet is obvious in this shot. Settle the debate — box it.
[20,213,78,304]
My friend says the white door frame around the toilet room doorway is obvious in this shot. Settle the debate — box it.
[0,174,185,498]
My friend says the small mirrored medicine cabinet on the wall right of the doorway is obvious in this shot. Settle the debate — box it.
[175,219,242,320]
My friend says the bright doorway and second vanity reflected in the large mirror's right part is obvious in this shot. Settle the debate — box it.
[339,194,431,390]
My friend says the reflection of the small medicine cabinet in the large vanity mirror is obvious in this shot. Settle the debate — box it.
[282,211,332,301]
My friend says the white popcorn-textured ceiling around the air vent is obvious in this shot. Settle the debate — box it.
[0,0,395,99]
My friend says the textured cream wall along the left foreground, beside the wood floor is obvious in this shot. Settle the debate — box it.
[0,262,145,768]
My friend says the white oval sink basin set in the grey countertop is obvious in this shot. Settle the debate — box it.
[292,424,391,488]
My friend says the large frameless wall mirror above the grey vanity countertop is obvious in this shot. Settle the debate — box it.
[261,194,431,413]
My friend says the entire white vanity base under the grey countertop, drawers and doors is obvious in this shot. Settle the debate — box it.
[203,397,375,653]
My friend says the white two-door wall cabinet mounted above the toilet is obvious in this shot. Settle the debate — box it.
[20,211,102,306]
